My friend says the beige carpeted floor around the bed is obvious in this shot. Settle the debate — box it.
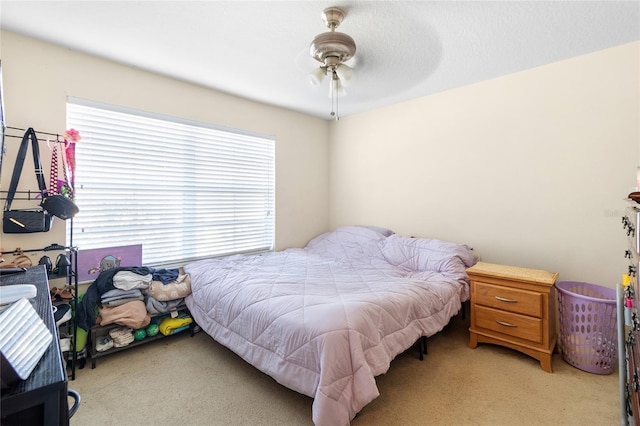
[69,316,620,426]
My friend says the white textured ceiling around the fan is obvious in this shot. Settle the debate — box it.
[0,0,640,119]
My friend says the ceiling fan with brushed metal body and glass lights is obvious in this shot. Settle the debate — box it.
[308,7,356,120]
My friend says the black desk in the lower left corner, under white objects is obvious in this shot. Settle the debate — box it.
[0,266,69,426]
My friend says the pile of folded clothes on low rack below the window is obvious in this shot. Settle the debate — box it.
[76,266,192,351]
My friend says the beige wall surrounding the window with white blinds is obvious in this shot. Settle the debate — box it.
[0,31,329,263]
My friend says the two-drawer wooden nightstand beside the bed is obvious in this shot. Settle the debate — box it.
[467,262,558,373]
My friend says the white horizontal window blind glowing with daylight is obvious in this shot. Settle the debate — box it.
[67,99,275,265]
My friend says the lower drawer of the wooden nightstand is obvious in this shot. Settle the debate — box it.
[472,305,542,343]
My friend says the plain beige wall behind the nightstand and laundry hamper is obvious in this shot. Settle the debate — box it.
[330,43,640,286]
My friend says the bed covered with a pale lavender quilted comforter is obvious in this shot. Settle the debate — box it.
[185,226,477,426]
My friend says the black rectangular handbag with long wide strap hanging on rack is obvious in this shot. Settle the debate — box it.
[2,127,53,234]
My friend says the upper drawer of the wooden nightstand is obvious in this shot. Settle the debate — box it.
[473,282,542,318]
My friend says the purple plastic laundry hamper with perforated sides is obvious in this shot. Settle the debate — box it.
[556,281,618,374]
